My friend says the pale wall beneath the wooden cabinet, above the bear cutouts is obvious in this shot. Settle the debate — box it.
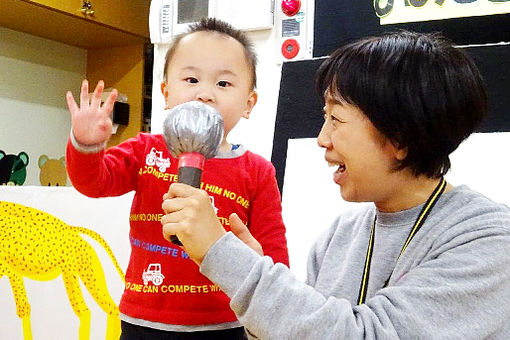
[0,27,87,185]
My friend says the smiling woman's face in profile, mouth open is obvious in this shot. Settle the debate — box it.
[318,95,405,205]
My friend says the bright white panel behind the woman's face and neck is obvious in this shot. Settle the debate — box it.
[282,133,510,280]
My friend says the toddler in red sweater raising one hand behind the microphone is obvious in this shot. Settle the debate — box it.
[67,19,288,339]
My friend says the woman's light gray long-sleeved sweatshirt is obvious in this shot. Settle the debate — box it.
[200,186,510,340]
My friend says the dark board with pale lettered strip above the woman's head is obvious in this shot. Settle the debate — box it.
[313,0,510,57]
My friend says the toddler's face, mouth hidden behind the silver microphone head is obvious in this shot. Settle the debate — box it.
[161,32,257,136]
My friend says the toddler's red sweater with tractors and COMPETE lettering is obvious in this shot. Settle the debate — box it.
[66,133,289,325]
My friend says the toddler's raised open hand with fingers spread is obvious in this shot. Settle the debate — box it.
[66,79,117,145]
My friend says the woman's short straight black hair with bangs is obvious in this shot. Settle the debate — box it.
[316,31,487,178]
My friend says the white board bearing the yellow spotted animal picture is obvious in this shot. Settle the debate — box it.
[0,185,133,340]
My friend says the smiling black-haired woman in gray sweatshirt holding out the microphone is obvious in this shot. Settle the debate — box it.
[161,32,510,340]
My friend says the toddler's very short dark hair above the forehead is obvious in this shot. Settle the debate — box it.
[163,18,257,89]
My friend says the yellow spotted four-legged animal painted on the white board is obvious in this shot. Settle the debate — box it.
[0,201,124,340]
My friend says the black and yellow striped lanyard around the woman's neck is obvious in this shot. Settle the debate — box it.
[358,178,446,305]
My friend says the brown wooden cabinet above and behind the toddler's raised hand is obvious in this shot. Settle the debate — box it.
[0,0,150,146]
